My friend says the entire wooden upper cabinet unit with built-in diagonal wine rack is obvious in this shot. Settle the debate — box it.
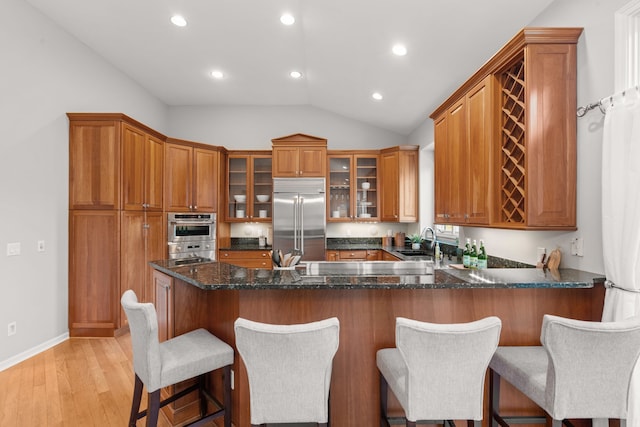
[431,28,582,230]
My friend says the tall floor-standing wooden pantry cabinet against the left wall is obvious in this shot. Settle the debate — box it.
[67,113,166,336]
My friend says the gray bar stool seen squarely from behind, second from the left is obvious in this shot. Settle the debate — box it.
[235,317,340,426]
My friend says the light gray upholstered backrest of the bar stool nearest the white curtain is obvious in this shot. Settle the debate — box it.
[540,315,640,420]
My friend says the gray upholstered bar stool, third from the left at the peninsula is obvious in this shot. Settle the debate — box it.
[376,316,502,427]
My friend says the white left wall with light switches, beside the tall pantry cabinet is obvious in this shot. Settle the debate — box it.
[0,0,167,369]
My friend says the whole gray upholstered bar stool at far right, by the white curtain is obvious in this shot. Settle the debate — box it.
[489,315,640,427]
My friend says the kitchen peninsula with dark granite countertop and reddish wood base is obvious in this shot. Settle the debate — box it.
[151,261,604,427]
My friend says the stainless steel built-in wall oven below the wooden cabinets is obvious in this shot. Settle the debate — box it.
[167,212,217,260]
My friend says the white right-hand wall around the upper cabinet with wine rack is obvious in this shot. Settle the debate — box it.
[410,0,628,273]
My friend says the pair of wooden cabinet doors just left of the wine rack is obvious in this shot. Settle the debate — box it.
[434,76,493,225]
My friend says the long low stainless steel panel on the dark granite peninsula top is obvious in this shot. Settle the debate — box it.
[303,260,433,276]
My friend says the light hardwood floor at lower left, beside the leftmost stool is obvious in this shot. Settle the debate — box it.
[0,333,185,427]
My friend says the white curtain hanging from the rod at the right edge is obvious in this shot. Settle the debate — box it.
[602,89,640,427]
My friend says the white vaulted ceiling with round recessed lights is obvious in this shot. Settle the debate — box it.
[26,0,553,135]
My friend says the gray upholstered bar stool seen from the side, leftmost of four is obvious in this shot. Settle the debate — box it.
[120,290,233,427]
